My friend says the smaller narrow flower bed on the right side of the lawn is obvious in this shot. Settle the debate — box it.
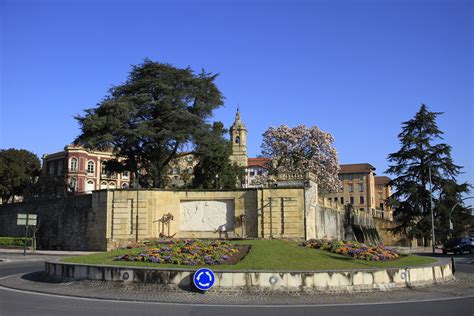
[300,239,400,261]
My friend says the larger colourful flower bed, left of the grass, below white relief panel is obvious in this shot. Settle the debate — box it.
[114,239,249,266]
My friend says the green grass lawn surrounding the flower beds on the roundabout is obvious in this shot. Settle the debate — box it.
[64,240,436,270]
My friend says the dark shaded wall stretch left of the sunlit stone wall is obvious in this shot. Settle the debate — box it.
[0,195,105,250]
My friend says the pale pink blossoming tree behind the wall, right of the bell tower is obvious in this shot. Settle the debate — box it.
[262,125,341,192]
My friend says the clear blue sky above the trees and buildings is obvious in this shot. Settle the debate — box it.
[0,0,474,183]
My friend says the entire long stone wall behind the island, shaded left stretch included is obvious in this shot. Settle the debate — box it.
[0,174,389,251]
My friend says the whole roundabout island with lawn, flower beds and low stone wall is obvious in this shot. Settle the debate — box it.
[45,239,454,295]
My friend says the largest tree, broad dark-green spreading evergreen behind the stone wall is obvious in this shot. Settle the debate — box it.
[76,60,224,188]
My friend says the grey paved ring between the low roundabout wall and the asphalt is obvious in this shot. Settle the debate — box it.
[0,272,474,305]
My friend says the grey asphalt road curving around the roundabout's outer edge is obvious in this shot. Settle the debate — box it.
[0,257,474,316]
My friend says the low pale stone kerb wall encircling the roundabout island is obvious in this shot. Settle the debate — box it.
[45,260,454,293]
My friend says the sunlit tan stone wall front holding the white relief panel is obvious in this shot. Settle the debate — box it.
[103,188,305,249]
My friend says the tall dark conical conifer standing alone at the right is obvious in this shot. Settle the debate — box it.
[386,104,470,241]
